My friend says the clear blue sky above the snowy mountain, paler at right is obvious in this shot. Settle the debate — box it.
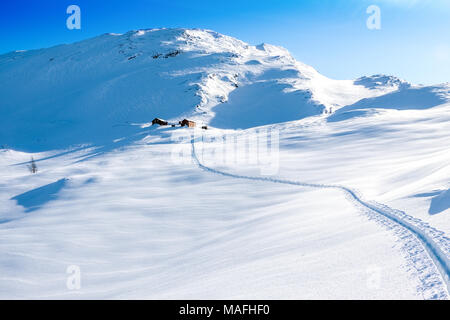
[0,0,450,84]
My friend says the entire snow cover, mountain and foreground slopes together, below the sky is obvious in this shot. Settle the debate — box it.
[0,29,450,299]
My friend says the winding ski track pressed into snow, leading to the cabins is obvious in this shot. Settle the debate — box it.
[191,139,450,300]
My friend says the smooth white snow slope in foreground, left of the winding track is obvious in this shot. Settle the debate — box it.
[0,141,430,299]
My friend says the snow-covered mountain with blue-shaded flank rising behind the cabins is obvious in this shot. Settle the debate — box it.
[0,29,448,151]
